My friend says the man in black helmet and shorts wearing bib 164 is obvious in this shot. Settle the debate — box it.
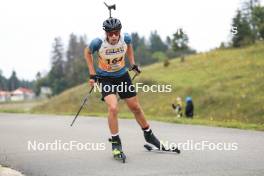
[85,17,163,159]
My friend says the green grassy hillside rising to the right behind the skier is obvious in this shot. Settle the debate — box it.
[29,43,264,130]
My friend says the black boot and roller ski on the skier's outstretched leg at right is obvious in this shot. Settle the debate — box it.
[144,129,181,154]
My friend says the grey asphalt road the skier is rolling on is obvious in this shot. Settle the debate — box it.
[0,114,264,176]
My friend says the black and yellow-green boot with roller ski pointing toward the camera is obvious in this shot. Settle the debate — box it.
[109,138,126,163]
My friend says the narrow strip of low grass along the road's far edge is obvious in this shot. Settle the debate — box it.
[0,101,264,131]
